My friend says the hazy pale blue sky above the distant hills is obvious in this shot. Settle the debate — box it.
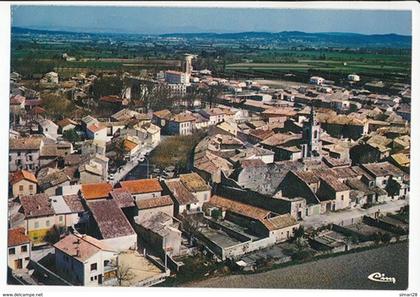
[12,6,411,35]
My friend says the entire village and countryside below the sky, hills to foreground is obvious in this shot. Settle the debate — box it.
[7,5,411,289]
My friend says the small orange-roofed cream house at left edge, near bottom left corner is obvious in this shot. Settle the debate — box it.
[7,228,32,270]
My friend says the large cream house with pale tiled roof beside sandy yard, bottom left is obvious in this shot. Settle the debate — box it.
[54,234,118,286]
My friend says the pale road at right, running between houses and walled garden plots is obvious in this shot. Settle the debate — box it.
[302,200,408,228]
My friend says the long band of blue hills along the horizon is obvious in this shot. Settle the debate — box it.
[12,27,412,48]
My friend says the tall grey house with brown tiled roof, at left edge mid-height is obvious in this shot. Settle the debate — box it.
[9,136,44,172]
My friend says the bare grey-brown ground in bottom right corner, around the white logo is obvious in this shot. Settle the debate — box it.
[187,242,408,290]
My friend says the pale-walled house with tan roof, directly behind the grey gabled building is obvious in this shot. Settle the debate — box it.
[136,195,174,221]
